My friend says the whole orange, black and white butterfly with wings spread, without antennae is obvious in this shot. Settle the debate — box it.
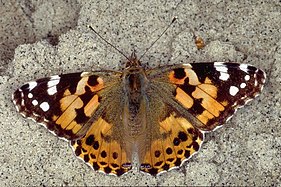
[13,52,266,176]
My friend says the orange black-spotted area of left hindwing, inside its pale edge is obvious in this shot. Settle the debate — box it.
[74,117,131,174]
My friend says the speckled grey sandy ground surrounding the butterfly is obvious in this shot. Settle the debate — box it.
[0,0,281,186]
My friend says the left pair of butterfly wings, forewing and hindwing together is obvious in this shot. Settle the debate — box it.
[13,72,131,175]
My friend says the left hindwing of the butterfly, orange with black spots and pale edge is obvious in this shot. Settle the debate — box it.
[71,117,132,176]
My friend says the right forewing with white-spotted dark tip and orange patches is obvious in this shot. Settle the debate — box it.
[154,62,266,131]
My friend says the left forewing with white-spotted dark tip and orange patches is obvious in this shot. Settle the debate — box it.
[13,72,116,140]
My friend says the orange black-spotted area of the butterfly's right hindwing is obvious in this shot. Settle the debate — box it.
[141,113,203,174]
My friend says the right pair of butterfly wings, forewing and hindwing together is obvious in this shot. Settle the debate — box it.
[139,62,265,175]
